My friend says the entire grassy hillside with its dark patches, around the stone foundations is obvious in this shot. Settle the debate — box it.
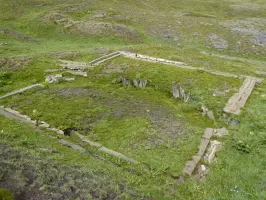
[0,0,266,199]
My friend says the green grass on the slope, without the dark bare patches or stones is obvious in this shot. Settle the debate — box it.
[0,0,266,199]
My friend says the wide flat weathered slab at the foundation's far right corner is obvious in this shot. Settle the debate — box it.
[224,77,257,115]
